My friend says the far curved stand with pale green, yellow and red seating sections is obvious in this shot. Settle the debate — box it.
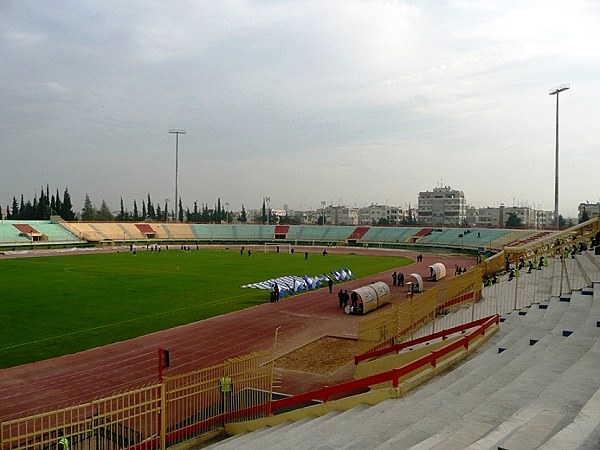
[0,220,548,249]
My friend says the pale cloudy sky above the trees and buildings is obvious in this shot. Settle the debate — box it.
[0,0,600,217]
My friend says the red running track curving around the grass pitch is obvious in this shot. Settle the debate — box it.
[0,248,475,420]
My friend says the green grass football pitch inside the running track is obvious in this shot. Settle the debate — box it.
[0,249,412,368]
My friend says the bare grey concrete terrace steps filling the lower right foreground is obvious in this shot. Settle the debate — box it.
[204,283,600,450]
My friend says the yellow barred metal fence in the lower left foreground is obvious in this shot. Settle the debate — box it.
[0,352,273,450]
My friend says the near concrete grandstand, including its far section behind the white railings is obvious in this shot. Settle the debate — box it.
[207,237,600,450]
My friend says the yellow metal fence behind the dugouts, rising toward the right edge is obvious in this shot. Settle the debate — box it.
[358,218,600,353]
